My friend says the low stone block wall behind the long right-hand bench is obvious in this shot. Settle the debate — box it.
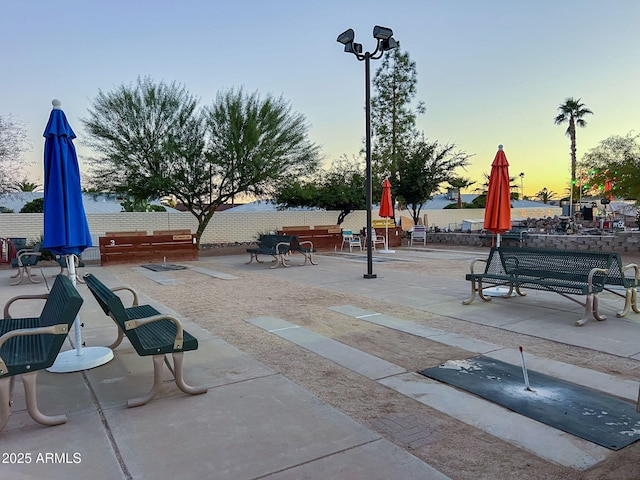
[427,231,640,252]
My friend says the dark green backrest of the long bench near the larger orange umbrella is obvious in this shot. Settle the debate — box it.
[487,247,614,285]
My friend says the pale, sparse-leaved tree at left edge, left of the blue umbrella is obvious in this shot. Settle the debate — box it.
[0,115,31,193]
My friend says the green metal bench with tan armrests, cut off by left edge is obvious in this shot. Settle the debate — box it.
[0,275,82,430]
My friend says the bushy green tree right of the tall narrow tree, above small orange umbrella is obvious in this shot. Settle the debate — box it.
[396,138,470,223]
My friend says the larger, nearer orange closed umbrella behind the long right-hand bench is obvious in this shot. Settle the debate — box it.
[484,145,511,247]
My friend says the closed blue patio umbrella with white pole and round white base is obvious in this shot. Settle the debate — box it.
[42,100,113,373]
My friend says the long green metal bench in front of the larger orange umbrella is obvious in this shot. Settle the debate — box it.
[462,247,614,326]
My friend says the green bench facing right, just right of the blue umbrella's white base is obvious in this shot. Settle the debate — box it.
[84,273,208,407]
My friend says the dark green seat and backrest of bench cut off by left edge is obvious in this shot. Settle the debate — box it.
[2,275,83,376]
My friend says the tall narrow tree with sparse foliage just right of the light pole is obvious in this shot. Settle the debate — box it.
[371,47,425,182]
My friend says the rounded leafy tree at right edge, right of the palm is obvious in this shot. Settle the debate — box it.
[580,132,640,200]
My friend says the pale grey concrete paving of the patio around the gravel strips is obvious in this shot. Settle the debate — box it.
[0,249,640,480]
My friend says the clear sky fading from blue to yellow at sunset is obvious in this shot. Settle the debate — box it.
[0,0,640,195]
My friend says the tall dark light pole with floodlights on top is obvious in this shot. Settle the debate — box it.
[337,25,398,278]
